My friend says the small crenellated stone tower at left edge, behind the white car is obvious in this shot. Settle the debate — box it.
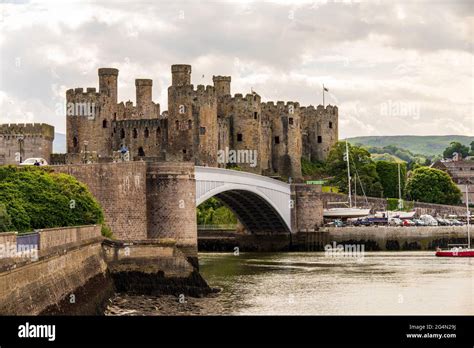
[0,123,54,165]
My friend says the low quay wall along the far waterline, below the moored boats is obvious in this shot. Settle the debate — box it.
[198,226,474,251]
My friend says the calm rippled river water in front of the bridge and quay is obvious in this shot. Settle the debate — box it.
[106,251,474,315]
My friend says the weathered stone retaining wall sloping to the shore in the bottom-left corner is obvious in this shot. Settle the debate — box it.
[0,239,113,315]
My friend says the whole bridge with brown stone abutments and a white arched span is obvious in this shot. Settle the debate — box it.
[51,161,323,252]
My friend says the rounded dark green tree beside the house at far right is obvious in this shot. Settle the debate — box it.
[406,167,461,205]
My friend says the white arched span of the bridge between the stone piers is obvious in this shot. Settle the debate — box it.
[195,166,291,234]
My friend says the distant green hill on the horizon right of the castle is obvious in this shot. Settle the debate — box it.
[347,135,474,156]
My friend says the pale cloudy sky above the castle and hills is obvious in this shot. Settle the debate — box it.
[0,0,474,138]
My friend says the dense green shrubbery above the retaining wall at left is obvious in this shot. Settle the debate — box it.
[0,166,104,232]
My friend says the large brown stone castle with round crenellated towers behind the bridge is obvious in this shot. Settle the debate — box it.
[66,64,338,180]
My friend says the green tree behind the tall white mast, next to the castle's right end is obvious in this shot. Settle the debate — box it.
[326,142,382,197]
